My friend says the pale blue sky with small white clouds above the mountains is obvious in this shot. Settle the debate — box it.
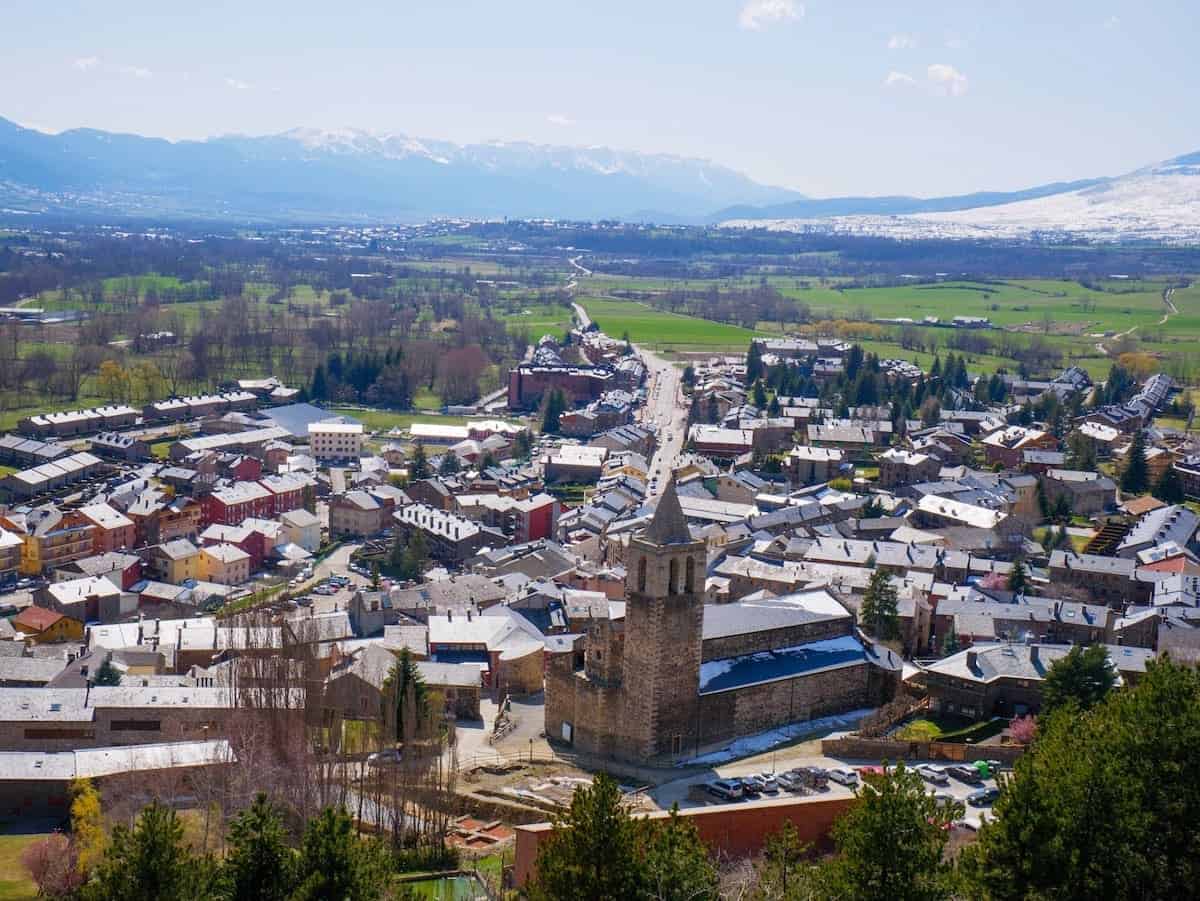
[0,0,1200,196]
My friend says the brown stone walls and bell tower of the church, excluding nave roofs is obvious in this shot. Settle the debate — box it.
[546,483,896,762]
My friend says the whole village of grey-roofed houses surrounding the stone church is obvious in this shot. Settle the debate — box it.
[0,311,1200,887]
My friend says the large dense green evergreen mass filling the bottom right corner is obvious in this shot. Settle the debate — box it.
[962,660,1200,901]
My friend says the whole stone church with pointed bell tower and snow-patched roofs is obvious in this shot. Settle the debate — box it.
[546,481,900,763]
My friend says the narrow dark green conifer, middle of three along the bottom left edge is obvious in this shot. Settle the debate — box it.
[223,792,294,901]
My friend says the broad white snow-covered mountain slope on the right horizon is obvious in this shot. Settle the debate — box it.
[725,154,1200,244]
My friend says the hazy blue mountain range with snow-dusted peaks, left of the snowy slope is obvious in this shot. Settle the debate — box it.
[0,119,798,222]
